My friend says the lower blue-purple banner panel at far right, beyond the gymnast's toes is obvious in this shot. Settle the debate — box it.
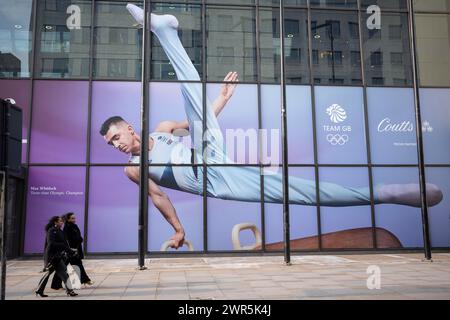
[426,168,450,248]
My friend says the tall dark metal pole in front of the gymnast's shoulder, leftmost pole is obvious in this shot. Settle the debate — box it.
[138,0,151,270]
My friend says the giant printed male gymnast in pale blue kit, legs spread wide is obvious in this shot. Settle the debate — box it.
[100,4,443,249]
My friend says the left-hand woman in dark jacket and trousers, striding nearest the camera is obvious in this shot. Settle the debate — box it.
[36,216,78,298]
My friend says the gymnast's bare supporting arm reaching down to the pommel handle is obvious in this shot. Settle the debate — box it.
[125,167,185,249]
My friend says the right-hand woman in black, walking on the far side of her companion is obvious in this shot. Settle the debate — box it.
[64,212,94,286]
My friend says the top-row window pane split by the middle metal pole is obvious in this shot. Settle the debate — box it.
[260,9,309,84]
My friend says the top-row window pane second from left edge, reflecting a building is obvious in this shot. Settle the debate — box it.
[35,0,91,78]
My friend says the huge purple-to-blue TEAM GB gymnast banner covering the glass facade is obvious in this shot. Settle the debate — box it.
[18,4,450,253]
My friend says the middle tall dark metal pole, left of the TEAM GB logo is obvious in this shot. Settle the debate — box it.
[280,0,291,265]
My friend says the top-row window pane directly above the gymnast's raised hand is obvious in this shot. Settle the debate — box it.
[206,6,257,81]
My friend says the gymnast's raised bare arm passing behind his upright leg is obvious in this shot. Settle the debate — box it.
[155,72,239,133]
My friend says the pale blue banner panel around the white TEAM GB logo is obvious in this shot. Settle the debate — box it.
[314,87,367,164]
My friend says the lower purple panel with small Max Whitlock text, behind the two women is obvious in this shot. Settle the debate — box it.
[24,167,85,254]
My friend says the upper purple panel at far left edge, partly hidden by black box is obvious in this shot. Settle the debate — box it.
[0,80,31,163]
